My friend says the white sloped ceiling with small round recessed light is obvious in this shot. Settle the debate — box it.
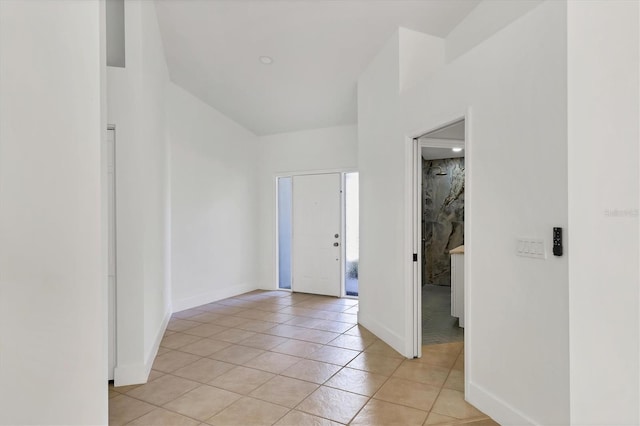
[156,0,480,135]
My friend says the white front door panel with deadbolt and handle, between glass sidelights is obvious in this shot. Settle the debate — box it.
[291,173,342,297]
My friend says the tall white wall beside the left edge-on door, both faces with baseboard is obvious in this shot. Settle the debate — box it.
[108,0,170,385]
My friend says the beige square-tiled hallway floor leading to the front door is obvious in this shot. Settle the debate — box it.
[109,291,496,426]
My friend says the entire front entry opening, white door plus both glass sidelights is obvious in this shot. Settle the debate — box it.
[276,172,359,297]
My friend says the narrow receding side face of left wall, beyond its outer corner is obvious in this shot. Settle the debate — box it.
[139,0,171,370]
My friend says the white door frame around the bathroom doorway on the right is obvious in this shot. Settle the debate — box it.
[405,107,473,372]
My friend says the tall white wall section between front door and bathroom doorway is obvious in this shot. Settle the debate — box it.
[358,33,413,357]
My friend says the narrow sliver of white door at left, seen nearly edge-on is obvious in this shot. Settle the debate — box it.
[107,129,116,380]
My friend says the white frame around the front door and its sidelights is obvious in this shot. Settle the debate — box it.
[272,167,359,299]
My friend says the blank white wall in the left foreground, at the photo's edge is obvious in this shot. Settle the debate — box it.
[0,1,107,425]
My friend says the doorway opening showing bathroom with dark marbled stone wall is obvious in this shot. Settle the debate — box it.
[415,120,466,345]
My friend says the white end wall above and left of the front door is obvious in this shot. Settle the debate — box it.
[256,125,358,289]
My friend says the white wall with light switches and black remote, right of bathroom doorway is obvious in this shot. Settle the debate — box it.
[403,1,571,424]
